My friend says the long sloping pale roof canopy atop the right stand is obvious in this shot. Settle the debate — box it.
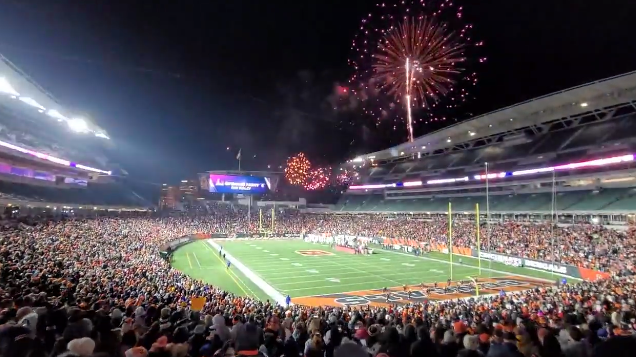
[354,71,636,161]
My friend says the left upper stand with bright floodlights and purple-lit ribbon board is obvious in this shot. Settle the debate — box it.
[0,54,159,214]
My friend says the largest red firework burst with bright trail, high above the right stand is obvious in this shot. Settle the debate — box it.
[349,0,486,141]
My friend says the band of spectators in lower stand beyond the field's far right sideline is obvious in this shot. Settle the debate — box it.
[296,215,636,275]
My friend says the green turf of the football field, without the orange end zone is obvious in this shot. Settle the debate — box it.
[173,240,572,303]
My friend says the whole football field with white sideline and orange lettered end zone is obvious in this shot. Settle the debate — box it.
[173,240,561,306]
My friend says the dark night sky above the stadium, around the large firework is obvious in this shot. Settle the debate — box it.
[0,0,636,182]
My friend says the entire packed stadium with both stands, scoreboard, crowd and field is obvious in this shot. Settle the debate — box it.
[0,58,636,356]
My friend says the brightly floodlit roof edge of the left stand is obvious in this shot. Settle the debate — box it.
[0,54,110,139]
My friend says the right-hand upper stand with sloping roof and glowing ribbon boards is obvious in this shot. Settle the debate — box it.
[335,72,636,221]
